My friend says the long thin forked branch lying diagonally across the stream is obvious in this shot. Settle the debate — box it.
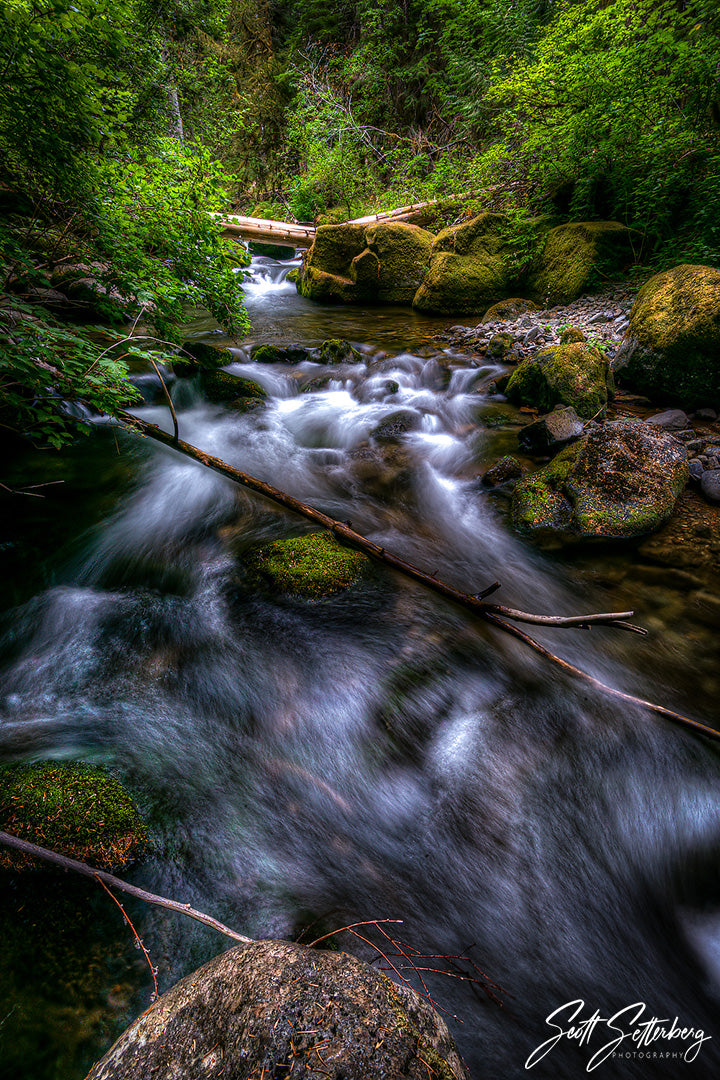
[118,411,720,742]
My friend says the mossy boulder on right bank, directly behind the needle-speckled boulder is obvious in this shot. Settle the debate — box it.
[505,342,614,419]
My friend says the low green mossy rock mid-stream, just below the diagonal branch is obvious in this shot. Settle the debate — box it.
[247,532,376,600]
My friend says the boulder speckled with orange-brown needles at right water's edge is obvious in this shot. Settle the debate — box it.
[512,420,688,540]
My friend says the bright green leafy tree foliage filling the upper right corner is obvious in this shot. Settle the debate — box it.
[484,0,720,254]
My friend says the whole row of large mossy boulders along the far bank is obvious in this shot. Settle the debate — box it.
[297,213,631,315]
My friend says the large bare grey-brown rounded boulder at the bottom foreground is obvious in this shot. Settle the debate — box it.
[87,941,468,1080]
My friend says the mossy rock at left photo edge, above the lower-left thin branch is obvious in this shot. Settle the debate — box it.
[0,761,148,869]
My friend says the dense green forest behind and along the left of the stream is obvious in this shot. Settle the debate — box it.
[0,0,720,445]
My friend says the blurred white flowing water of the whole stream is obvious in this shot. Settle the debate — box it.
[0,259,720,1080]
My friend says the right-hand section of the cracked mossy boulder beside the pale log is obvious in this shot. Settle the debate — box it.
[365,221,435,303]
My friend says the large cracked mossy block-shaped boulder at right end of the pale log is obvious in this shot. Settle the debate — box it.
[298,221,433,303]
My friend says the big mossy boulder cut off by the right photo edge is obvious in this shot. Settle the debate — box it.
[614,265,720,408]
